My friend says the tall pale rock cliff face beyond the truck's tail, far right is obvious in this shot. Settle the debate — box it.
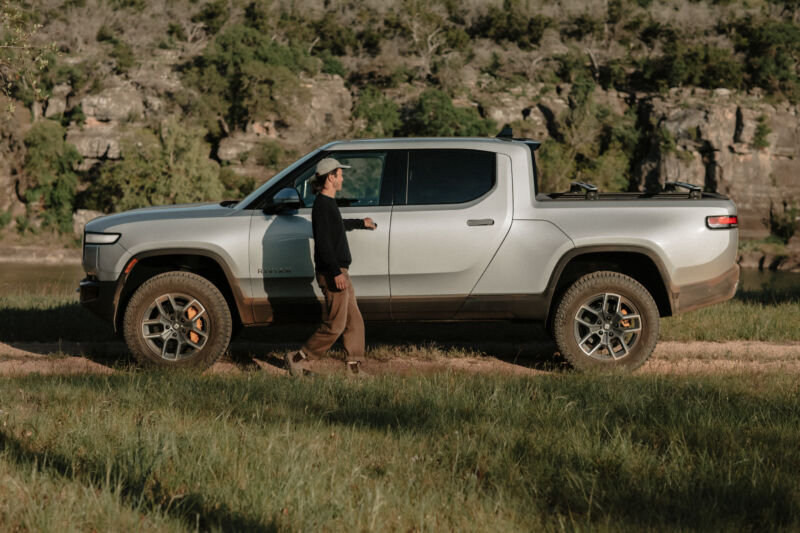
[639,89,800,238]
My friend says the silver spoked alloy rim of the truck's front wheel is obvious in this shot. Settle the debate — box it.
[142,293,211,361]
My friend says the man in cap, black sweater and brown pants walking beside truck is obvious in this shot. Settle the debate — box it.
[284,157,377,377]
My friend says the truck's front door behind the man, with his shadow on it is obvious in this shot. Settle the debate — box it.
[245,151,391,323]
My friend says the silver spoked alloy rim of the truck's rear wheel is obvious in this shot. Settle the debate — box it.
[573,293,642,361]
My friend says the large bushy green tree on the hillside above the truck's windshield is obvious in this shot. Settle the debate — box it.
[181,18,317,136]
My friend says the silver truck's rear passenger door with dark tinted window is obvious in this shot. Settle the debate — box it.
[389,150,513,320]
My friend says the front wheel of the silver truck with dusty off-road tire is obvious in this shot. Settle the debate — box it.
[122,271,233,370]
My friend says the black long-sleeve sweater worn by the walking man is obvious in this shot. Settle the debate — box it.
[311,193,366,279]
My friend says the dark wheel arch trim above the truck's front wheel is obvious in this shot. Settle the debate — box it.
[113,249,252,331]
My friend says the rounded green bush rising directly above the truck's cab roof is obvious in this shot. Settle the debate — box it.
[404,89,496,137]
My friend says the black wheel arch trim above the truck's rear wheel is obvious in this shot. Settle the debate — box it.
[547,246,674,326]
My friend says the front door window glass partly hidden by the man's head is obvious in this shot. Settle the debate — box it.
[294,152,386,207]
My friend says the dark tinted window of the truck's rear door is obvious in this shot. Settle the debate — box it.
[407,150,495,205]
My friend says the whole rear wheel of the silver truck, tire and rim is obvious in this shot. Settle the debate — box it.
[553,271,659,371]
